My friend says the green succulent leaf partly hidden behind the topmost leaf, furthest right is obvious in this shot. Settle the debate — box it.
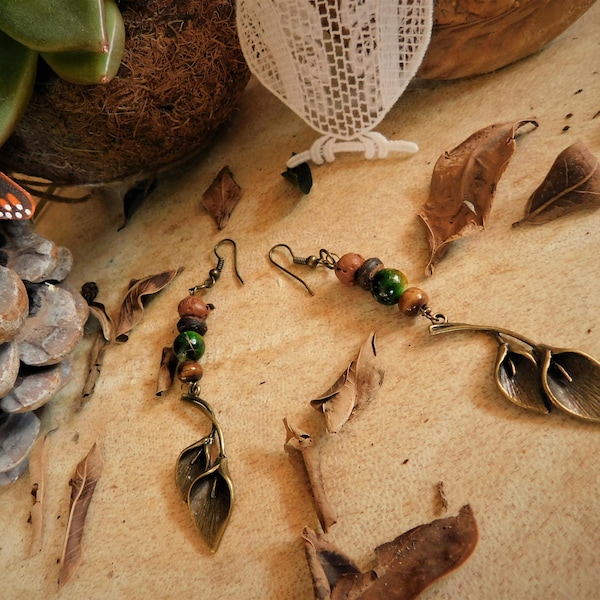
[41,0,125,85]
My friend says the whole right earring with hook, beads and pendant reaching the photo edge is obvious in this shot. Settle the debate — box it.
[269,244,600,422]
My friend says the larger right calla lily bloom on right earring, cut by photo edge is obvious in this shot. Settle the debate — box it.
[537,346,600,422]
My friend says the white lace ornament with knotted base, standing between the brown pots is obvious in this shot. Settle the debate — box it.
[237,0,433,166]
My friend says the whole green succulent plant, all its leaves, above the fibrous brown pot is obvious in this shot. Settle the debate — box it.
[0,0,125,146]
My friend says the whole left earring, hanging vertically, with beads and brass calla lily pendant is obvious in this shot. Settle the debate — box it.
[163,238,244,552]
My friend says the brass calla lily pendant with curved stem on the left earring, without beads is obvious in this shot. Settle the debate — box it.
[175,394,234,552]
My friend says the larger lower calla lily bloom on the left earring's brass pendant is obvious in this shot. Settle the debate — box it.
[188,457,233,552]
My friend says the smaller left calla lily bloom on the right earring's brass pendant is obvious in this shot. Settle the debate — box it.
[495,342,550,414]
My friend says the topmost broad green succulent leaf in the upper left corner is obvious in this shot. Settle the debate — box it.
[0,0,107,52]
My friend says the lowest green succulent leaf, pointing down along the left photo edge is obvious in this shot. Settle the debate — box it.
[0,31,37,146]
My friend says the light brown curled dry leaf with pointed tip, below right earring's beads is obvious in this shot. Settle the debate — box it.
[310,331,385,433]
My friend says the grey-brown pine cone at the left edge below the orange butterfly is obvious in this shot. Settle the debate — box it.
[0,221,88,485]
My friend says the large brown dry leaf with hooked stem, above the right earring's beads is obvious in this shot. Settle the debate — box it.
[419,119,538,275]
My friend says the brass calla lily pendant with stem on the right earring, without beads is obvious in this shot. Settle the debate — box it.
[429,321,600,422]
